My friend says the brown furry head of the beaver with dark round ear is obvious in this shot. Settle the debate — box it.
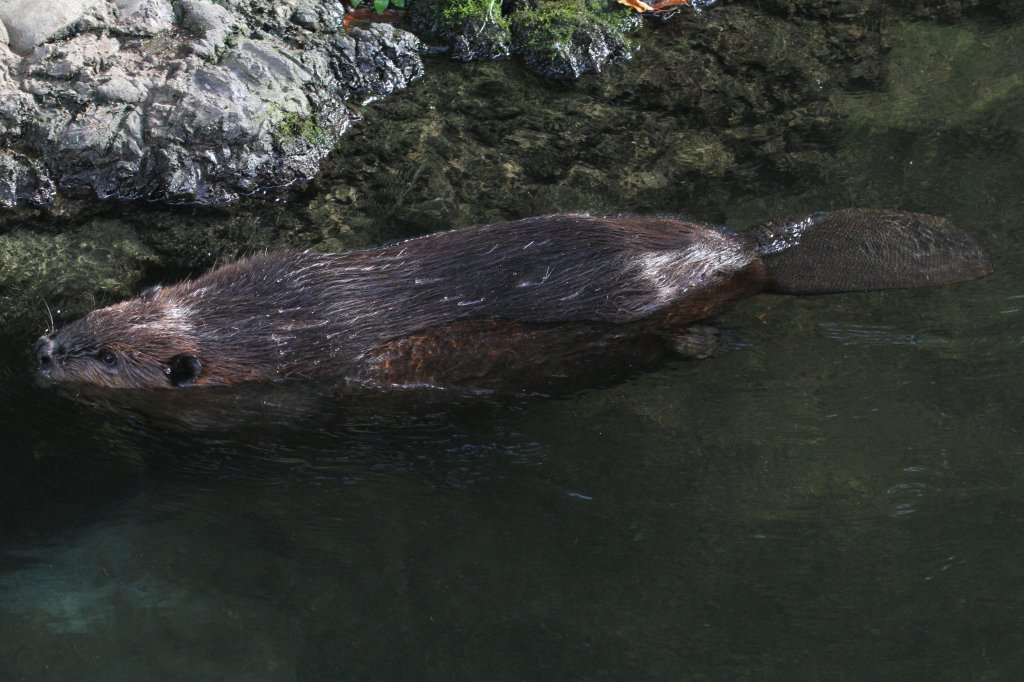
[35,287,203,388]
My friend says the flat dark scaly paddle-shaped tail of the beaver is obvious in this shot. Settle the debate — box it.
[748,209,992,294]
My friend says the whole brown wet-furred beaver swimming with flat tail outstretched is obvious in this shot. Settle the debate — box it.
[35,209,991,388]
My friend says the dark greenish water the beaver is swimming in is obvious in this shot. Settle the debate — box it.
[0,15,1024,680]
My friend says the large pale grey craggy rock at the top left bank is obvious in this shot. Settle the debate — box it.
[0,0,423,208]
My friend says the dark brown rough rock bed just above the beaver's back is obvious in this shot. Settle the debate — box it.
[307,0,905,236]
